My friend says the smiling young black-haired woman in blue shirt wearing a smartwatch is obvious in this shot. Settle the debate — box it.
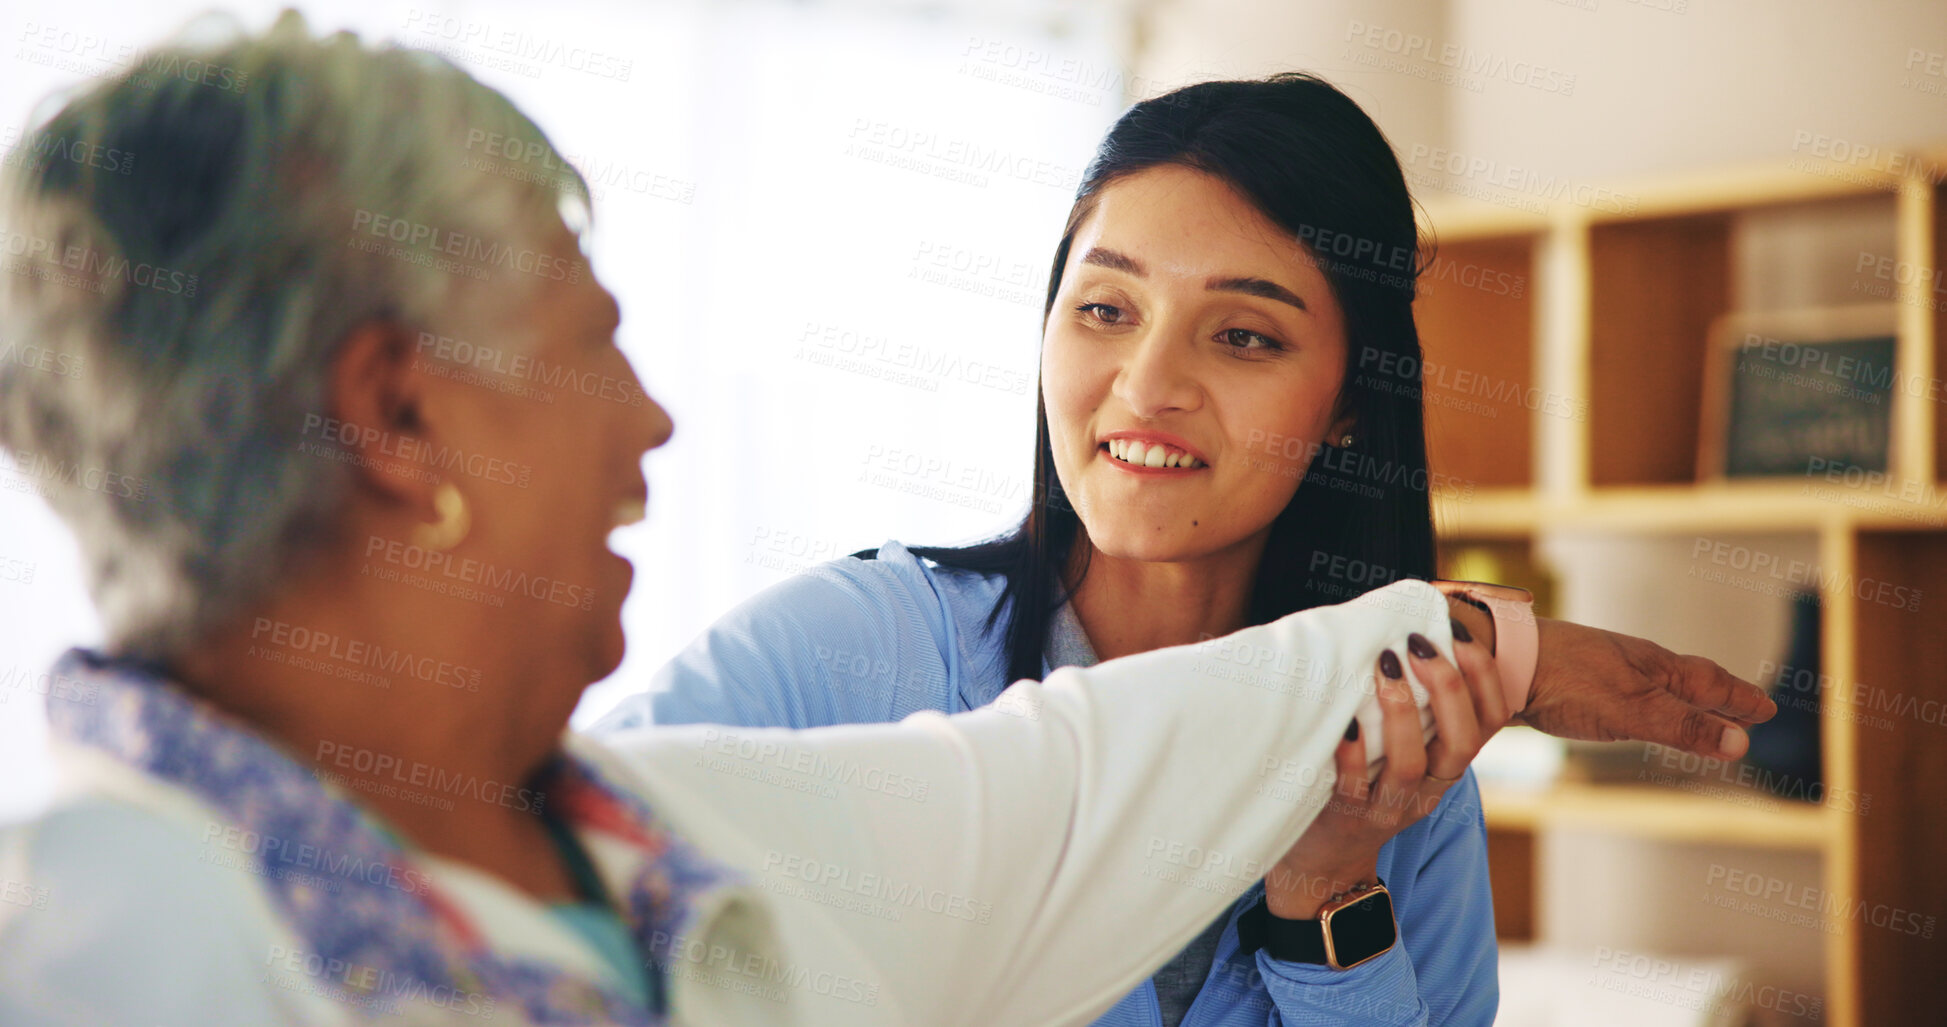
[602,74,1767,1027]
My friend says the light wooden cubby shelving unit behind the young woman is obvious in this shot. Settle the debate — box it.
[1417,148,1947,1027]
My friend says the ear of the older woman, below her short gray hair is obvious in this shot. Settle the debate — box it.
[319,320,438,511]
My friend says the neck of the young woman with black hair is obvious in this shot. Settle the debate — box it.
[1067,532,1266,661]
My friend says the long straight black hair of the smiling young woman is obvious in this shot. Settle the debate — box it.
[913,72,1435,680]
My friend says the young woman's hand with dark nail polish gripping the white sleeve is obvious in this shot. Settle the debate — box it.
[1264,608,1507,920]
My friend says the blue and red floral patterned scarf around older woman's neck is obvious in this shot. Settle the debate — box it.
[49,649,740,1027]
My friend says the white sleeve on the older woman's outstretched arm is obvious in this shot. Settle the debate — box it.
[604,581,1452,1025]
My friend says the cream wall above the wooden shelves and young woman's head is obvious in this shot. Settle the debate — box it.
[1135,0,1947,185]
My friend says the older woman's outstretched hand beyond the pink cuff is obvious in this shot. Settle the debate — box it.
[1515,618,1778,760]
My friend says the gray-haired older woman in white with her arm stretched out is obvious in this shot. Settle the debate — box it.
[0,16,1770,1025]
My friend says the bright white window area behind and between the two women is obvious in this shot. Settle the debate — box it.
[0,0,1131,815]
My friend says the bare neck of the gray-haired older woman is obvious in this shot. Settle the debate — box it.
[169,561,584,896]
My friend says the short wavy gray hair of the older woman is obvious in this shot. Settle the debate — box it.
[0,12,588,659]
